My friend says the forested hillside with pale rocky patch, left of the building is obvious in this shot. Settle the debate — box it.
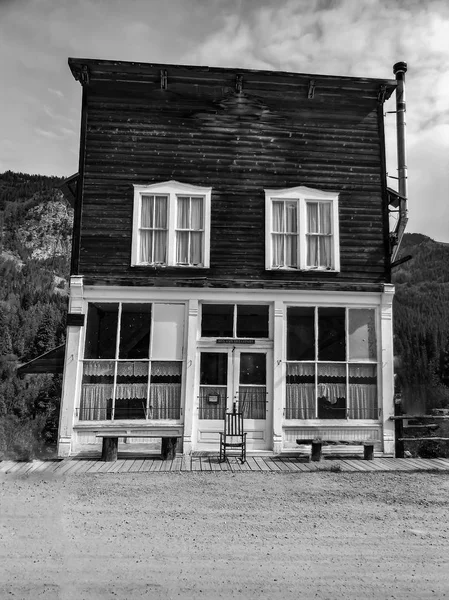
[0,171,73,458]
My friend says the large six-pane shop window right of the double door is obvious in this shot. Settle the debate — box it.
[285,307,379,420]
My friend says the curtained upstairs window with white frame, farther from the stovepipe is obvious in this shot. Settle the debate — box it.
[131,181,212,267]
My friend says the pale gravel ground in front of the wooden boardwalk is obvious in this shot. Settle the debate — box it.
[0,472,449,600]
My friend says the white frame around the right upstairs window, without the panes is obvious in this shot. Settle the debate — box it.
[264,186,340,272]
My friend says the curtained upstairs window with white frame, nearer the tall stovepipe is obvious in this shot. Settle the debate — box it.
[265,186,340,271]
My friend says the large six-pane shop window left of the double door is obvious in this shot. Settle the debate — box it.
[79,302,184,421]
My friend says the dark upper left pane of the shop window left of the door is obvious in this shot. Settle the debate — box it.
[84,303,118,358]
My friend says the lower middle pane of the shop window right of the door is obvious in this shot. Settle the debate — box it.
[317,364,346,419]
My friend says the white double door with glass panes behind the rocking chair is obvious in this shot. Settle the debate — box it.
[198,346,272,450]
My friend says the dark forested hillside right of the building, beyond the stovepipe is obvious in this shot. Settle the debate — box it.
[393,233,449,411]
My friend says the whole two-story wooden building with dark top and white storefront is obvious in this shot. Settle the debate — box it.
[59,59,406,456]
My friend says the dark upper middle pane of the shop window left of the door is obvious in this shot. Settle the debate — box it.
[119,304,151,358]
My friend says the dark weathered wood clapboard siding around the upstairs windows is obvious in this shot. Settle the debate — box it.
[68,60,394,290]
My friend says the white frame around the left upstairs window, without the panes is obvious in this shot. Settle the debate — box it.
[131,180,212,269]
